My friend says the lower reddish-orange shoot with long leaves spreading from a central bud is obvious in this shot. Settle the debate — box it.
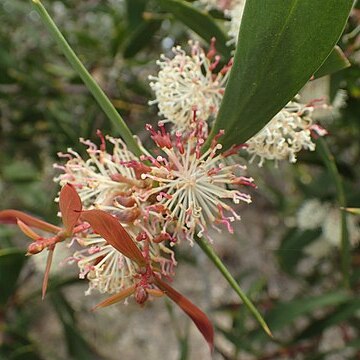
[81,210,214,349]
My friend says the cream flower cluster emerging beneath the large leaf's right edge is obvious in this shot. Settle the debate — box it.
[246,101,326,166]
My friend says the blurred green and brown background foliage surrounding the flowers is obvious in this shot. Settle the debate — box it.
[0,0,360,360]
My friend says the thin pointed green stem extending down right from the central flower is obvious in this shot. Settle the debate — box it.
[195,237,273,337]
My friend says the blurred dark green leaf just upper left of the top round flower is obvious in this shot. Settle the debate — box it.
[123,19,162,59]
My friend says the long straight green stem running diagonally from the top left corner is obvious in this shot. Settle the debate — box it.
[32,0,141,156]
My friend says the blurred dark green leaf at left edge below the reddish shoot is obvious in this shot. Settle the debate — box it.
[0,248,26,307]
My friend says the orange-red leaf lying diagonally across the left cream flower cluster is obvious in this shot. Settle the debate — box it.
[81,210,146,266]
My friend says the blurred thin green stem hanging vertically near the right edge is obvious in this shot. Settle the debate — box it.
[317,137,351,288]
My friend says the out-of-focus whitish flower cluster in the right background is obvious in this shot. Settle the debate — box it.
[297,199,360,257]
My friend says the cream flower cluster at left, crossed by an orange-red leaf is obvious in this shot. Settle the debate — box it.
[56,132,176,294]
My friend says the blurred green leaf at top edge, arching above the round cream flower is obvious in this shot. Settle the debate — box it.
[157,0,231,59]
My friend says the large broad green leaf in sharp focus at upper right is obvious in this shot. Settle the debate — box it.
[207,0,353,150]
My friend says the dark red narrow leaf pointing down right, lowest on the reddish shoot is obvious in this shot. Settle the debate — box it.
[155,278,214,350]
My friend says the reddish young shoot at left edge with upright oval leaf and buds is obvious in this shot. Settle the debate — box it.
[0,185,83,298]
